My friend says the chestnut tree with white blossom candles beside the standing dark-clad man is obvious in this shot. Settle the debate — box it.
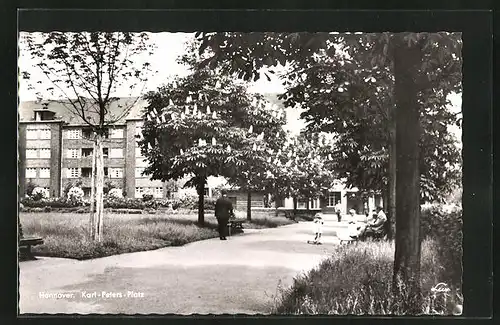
[139,73,285,224]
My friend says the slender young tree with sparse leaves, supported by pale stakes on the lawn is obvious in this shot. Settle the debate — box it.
[21,32,154,241]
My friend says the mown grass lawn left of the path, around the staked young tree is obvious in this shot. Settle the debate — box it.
[19,212,293,260]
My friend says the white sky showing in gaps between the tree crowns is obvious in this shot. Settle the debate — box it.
[18,33,462,140]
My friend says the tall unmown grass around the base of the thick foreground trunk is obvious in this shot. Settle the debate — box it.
[274,240,463,315]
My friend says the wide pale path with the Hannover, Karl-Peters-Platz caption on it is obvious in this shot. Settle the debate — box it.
[19,216,354,314]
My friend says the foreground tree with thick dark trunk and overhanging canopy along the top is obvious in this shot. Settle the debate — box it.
[197,33,461,313]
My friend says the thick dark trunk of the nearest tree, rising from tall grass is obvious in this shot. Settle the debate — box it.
[393,34,421,314]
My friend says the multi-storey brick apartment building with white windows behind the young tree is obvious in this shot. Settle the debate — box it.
[18,98,172,198]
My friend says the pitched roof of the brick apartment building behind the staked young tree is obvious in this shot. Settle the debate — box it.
[18,97,147,125]
